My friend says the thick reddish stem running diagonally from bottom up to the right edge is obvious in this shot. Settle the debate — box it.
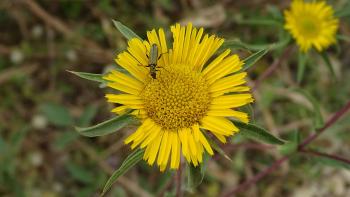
[222,101,350,197]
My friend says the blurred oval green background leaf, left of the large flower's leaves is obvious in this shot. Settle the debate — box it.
[39,103,73,127]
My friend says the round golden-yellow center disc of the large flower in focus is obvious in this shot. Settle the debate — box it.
[141,64,211,130]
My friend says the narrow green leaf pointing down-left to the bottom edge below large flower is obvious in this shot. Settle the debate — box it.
[101,149,144,196]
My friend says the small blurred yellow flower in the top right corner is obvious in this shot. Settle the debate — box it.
[284,0,339,52]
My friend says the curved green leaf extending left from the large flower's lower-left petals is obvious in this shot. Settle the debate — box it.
[75,114,135,137]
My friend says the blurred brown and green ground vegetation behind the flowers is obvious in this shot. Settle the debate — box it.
[0,0,350,197]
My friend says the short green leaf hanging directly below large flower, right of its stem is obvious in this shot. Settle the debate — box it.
[187,164,205,192]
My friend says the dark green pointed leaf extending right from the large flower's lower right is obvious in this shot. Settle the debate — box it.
[231,120,285,145]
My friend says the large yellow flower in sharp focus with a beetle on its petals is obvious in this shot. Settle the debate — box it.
[105,24,253,171]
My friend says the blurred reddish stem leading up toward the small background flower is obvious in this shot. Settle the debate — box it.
[252,46,293,91]
